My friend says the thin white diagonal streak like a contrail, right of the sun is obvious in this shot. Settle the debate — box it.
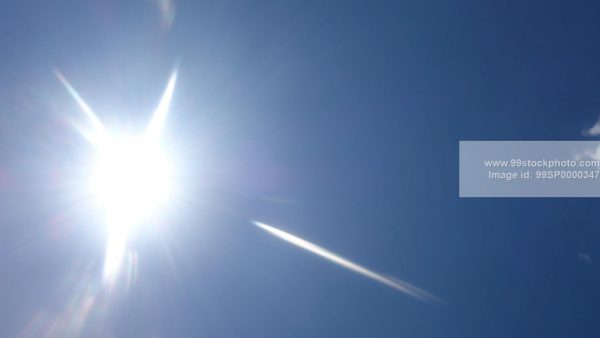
[252,222,440,302]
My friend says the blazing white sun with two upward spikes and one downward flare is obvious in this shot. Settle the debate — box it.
[56,70,177,286]
